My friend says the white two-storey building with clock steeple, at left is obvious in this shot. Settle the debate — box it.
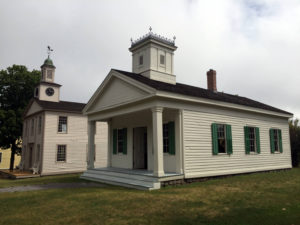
[21,56,107,175]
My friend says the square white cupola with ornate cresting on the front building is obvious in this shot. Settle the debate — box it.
[129,27,177,84]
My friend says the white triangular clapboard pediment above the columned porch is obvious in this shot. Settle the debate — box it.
[86,76,150,113]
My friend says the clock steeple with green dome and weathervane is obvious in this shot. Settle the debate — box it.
[34,46,61,102]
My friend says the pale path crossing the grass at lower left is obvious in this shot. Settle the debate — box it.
[0,183,105,193]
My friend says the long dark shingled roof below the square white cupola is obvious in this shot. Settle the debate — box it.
[113,69,293,115]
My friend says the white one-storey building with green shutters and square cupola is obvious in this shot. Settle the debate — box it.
[82,31,292,189]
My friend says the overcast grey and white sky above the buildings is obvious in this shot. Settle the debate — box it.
[0,0,300,118]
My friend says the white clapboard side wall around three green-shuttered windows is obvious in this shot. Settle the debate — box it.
[183,107,291,178]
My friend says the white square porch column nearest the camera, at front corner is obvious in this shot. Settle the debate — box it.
[151,107,164,177]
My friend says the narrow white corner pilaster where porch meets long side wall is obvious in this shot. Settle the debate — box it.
[175,110,183,174]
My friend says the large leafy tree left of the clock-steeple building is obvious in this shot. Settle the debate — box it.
[0,65,40,170]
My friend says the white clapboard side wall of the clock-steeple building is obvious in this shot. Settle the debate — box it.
[43,112,107,174]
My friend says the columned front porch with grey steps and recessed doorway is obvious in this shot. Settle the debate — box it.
[81,105,183,190]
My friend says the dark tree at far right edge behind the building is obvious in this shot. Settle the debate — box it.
[289,119,300,167]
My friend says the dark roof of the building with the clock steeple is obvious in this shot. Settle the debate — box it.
[23,98,86,117]
